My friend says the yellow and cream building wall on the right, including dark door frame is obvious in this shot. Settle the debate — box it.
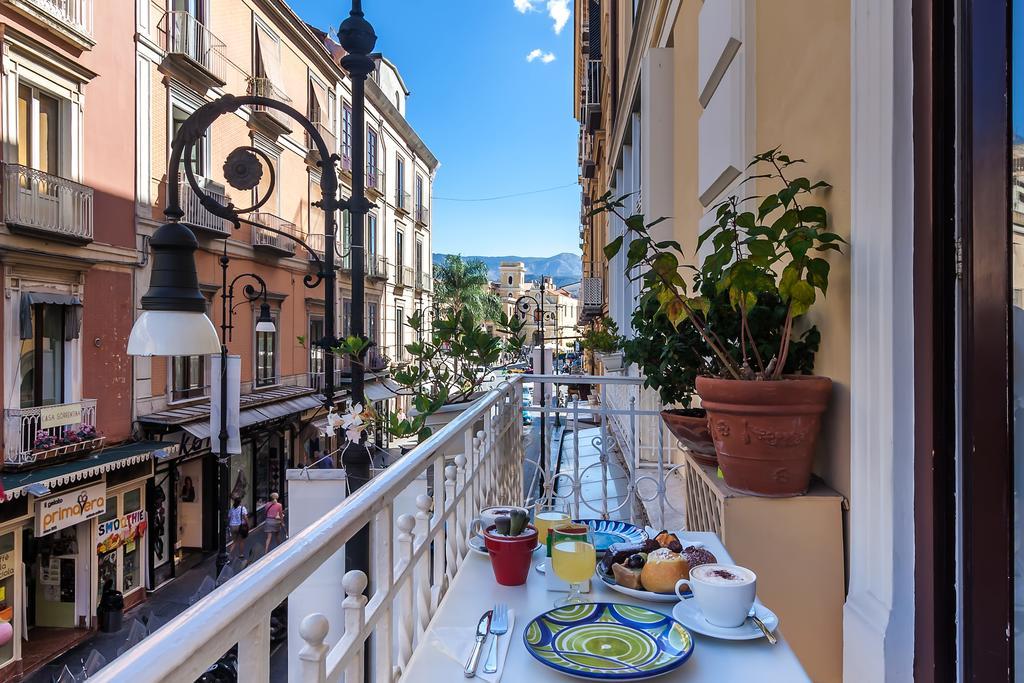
[573,0,1024,681]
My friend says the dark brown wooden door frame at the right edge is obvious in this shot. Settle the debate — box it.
[912,0,1014,683]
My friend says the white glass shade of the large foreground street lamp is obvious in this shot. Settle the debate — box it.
[128,310,220,355]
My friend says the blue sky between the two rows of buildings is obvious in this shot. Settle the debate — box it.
[290,0,580,256]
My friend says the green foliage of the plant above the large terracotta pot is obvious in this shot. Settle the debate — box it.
[594,147,844,385]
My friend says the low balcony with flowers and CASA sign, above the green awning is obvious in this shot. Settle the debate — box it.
[3,398,103,469]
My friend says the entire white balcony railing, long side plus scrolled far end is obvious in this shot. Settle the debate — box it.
[96,375,683,683]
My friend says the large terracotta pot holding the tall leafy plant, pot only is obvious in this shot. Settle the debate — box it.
[697,375,831,498]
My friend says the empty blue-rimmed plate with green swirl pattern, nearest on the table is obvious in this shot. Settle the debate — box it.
[522,602,693,681]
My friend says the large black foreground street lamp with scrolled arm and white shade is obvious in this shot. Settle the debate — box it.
[128,0,377,572]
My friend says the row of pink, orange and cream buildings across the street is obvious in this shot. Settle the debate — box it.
[0,0,438,681]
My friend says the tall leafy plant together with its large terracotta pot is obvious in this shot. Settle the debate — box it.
[597,147,844,496]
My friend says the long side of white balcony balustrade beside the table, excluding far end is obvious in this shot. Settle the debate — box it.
[90,379,523,683]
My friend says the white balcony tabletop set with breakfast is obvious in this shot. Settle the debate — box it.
[402,531,810,683]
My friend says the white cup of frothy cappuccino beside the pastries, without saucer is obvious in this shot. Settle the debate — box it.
[676,564,758,629]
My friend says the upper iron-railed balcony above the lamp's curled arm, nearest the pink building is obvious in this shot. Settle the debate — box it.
[160,10,227,88]
